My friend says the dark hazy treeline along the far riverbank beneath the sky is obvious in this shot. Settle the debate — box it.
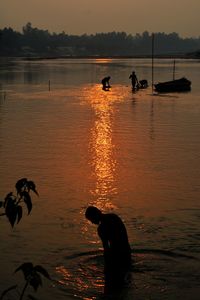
[0,22,200,58]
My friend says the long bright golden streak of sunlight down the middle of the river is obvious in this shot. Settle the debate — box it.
[85,85,126,209]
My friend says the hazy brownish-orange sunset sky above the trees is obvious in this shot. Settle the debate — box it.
[0,0,200,37]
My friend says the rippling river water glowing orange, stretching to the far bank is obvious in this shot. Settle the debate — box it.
[0,59,200,300]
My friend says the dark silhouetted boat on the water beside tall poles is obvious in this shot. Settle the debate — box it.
[154,77,191,93]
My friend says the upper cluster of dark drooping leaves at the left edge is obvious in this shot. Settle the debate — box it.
[0,178,39,227]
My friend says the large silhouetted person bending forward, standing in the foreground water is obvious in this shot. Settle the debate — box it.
[85,206,131,289]
